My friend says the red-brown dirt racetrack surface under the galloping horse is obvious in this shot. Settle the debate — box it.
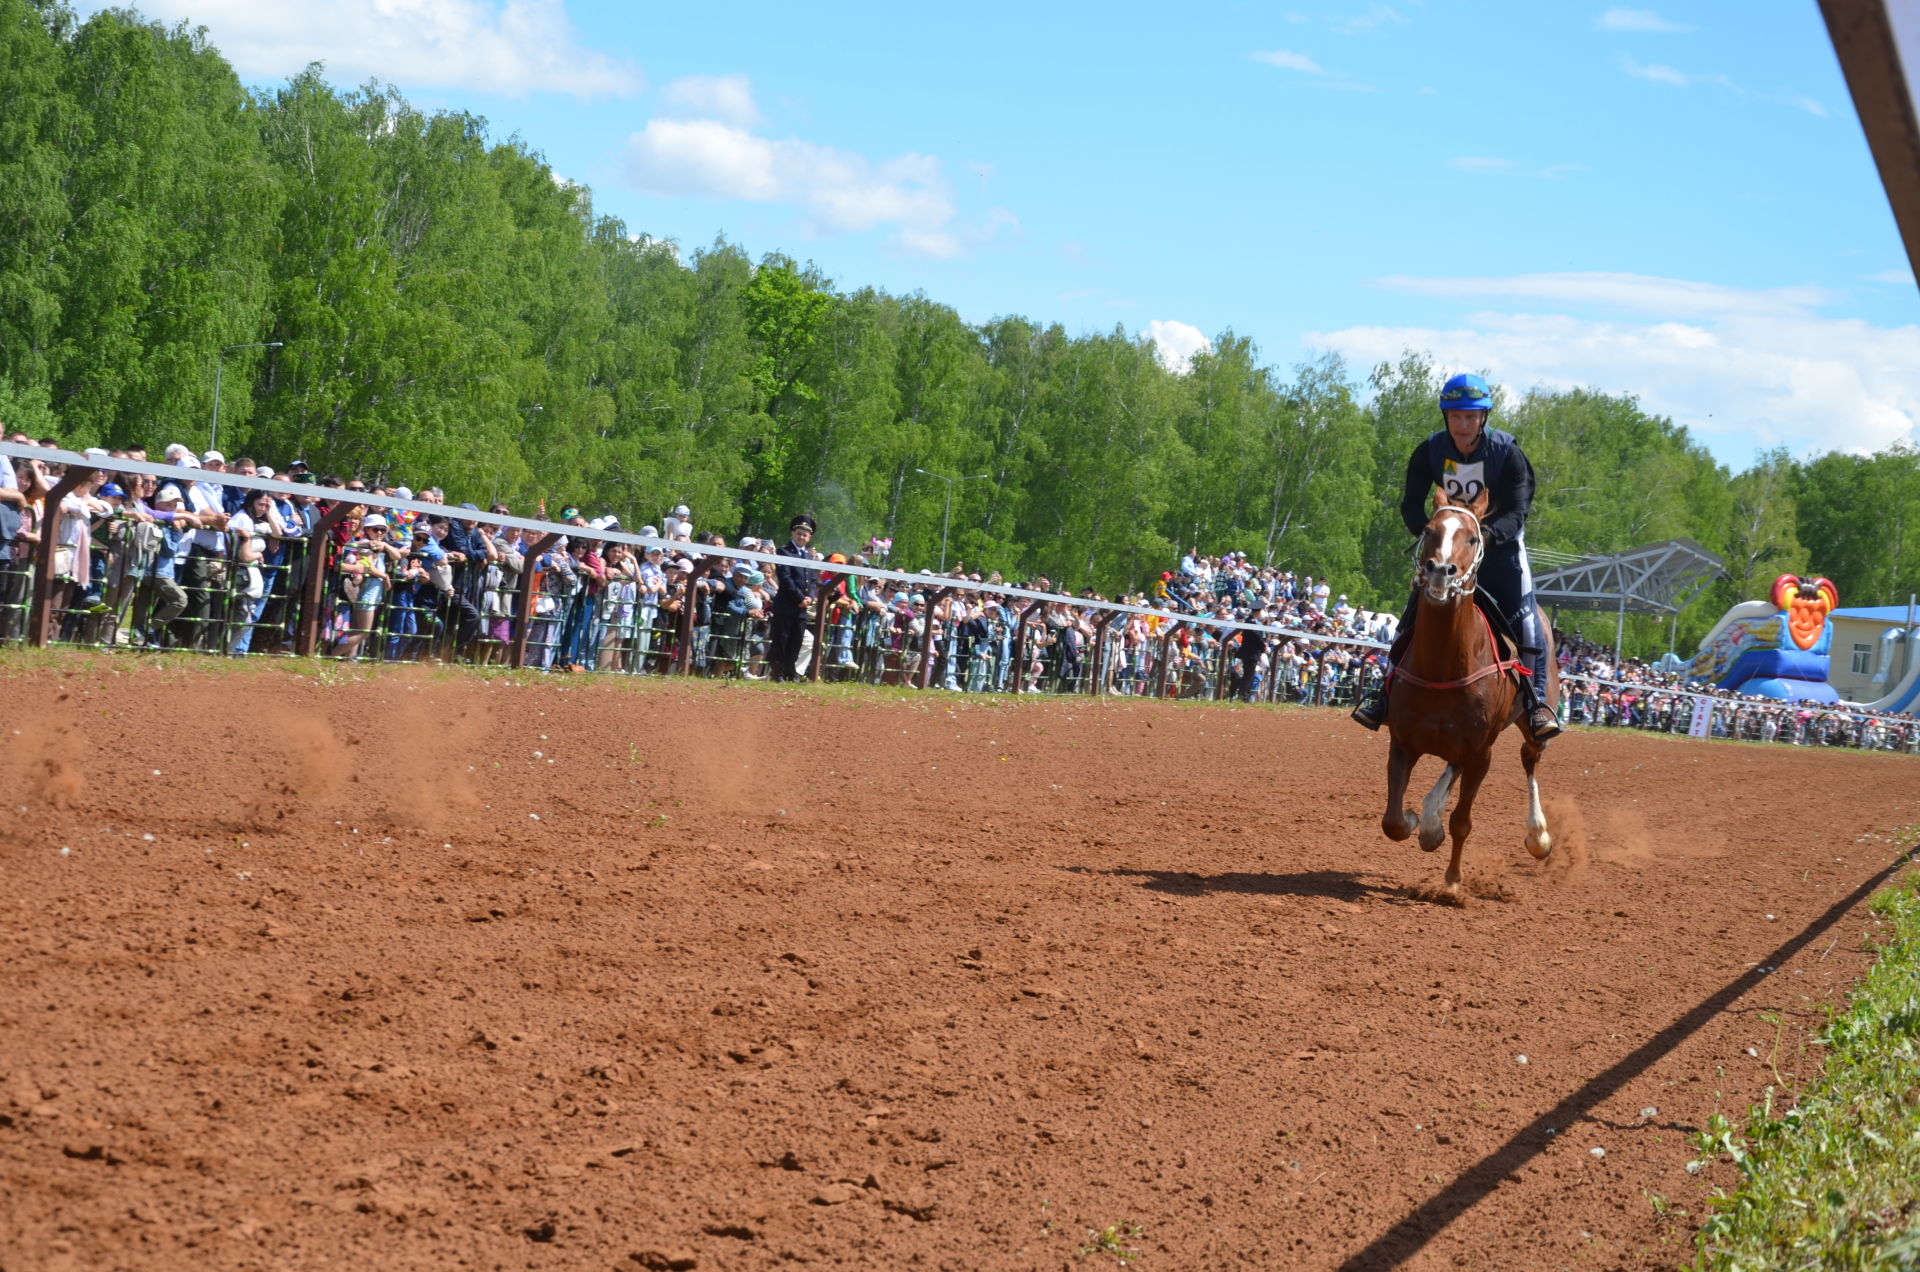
[0,657,1920,1272]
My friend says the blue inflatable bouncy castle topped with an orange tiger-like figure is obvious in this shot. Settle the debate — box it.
[1684,575,1839,701]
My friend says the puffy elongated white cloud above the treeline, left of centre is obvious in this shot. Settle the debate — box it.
[626,119,1020,257]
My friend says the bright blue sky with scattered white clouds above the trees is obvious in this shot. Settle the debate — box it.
[86,0,1920,469]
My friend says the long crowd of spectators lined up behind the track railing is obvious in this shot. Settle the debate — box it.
[0,432,1914,746]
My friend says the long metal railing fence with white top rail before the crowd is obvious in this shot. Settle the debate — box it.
[0,444,1920,749]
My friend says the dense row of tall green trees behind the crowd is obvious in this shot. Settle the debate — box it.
[0,0,1920,649]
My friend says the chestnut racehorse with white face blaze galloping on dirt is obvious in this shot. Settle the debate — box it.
[1380,490,1559,895]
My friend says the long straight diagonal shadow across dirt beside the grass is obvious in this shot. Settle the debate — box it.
[1338,847,1920,1272]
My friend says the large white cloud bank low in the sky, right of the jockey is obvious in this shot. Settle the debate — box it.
[1302,275,1920,467]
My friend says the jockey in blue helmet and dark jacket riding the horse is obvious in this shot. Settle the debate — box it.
[1354,375,1561,744]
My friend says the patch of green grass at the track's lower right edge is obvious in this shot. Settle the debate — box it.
[1693,832,1920,1272]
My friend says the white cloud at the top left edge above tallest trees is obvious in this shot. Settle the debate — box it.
[110,0,641,98]
